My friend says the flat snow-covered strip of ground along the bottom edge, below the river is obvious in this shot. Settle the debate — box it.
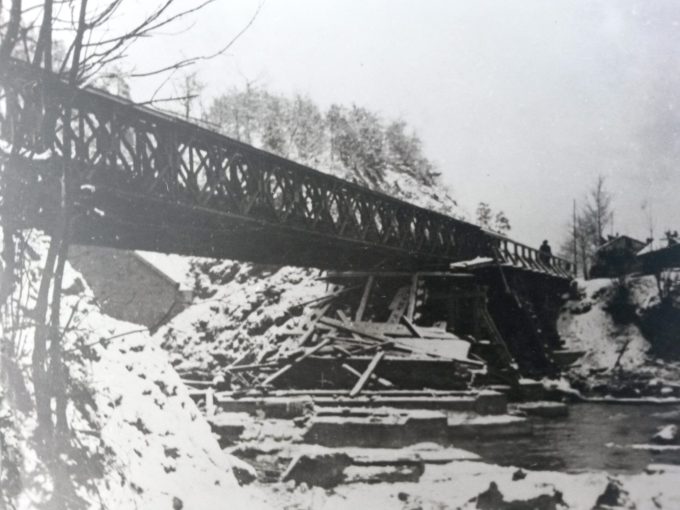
[252,454,680,510]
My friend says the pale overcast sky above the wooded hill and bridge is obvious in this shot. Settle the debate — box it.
[107,0,680,249]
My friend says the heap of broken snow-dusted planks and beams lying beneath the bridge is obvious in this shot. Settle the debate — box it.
[226,276,486,397]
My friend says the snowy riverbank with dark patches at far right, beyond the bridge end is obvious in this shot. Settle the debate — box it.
[558,274,680,396]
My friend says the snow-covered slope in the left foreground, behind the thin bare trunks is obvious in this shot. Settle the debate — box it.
[0,235,253,509]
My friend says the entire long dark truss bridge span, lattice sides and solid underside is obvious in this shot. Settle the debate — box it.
[0,60,572,278]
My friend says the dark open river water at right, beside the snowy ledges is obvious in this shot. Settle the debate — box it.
[456,404,680,473]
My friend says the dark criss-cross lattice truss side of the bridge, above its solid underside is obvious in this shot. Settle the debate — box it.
[0,60,490,261]
